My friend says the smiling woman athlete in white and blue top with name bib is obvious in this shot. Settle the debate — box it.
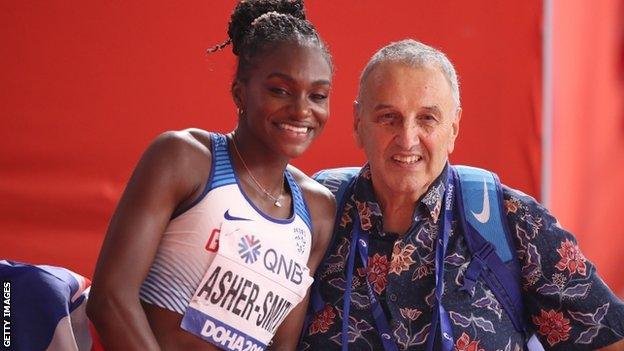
[87,0,335,350]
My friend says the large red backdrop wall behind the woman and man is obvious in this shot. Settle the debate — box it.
[0,0,616,296]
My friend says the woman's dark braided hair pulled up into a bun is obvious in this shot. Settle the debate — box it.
[208,0,332,81]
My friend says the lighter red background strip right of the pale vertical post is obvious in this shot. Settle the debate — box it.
[551,0,624,297]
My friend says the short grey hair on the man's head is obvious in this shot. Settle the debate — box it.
[358,39,461,107]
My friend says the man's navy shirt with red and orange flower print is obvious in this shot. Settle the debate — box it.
[299,165,624,351]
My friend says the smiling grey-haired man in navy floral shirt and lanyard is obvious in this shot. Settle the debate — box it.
[300,40,624,351]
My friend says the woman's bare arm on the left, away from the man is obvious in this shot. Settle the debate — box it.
[87,132,210,350]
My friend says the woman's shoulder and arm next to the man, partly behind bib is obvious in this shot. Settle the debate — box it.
[271,167,336,350]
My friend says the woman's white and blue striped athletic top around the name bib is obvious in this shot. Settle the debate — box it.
[139,133,312,314]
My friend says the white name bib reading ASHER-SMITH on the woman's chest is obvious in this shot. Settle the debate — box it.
[181,221,313,351]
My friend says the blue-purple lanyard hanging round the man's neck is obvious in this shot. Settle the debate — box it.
[341,166,456,351]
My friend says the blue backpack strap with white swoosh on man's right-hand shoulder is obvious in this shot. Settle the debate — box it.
[453,166,526,333]
